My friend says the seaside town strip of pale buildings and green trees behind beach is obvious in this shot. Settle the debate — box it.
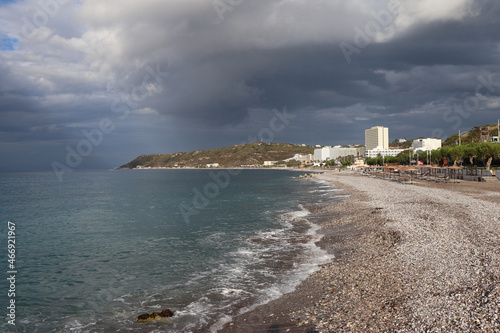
[133,120,500,182]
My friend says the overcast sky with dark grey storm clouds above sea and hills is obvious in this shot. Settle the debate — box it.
[0,0,500,170]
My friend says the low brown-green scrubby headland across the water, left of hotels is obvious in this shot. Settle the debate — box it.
[120,142,314,169]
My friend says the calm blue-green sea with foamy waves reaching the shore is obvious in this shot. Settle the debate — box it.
[0,169,343,333]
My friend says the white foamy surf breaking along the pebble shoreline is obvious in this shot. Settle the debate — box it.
[116,183,333,332]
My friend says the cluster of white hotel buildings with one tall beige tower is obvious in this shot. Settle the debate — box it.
[314,126,442,162]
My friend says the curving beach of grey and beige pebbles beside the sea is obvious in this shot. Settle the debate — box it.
[220,171,500,332]
